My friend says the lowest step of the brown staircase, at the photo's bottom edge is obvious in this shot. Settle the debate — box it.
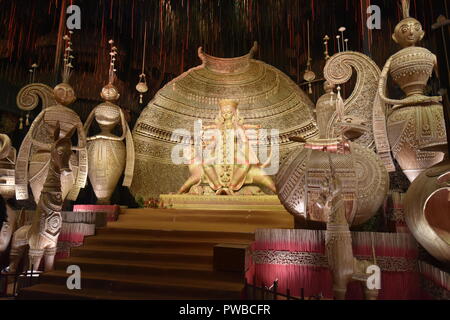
[18,284,218,300]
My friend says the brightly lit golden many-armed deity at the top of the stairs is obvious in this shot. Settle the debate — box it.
[178,99,276,195]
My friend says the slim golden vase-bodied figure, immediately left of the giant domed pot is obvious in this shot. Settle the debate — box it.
[84,41,134,204]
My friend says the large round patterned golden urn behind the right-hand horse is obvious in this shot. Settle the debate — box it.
[276,139,389,227]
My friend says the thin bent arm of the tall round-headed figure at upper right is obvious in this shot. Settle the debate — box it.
[378,57,442,109]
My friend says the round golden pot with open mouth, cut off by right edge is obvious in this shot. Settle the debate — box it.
[404,160,450,263]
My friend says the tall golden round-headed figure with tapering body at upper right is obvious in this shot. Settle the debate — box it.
[378,0,446,182]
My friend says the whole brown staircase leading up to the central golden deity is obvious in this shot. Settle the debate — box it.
[19,209,293,299]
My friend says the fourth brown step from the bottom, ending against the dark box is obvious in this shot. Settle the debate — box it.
[70,245,213,263]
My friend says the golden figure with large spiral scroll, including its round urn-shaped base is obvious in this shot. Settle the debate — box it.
[276,41,393,228]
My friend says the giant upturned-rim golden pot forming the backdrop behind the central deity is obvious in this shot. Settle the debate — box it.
[130,42,317,199]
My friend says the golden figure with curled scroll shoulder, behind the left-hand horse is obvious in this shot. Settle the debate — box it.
[15,33,87,203]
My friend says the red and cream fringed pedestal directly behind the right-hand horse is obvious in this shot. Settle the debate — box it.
[253,229,421,300]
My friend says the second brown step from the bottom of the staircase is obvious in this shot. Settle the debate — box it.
[34,271,244,299]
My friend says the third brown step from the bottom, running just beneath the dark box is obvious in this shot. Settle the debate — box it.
[54,257,243,282]
